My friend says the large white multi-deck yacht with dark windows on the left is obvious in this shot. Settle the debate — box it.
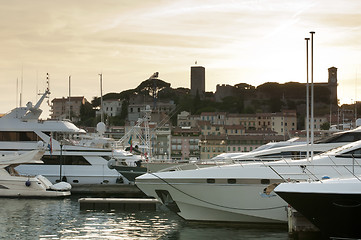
[0,89,135,185]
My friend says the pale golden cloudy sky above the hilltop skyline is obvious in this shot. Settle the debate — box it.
[0,0,361,117]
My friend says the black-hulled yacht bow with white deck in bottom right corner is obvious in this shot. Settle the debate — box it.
[275,176,361,239]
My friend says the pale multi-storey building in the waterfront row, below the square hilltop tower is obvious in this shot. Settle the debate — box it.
[172,127,200,160]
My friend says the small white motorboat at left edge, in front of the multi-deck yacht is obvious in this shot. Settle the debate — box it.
[0,150,71,197]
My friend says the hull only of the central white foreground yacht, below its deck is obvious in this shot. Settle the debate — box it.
[136,175,287,224]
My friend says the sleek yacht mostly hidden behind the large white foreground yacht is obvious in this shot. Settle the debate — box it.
[116,127,361,182]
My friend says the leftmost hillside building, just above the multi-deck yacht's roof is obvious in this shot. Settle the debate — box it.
[50,97,87,122]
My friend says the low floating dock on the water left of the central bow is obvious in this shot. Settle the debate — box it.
[78,198,159,211]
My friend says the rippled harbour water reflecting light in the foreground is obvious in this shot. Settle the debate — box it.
[0,197,288,240]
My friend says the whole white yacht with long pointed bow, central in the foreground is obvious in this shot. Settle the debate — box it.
[136,141,361,224]
